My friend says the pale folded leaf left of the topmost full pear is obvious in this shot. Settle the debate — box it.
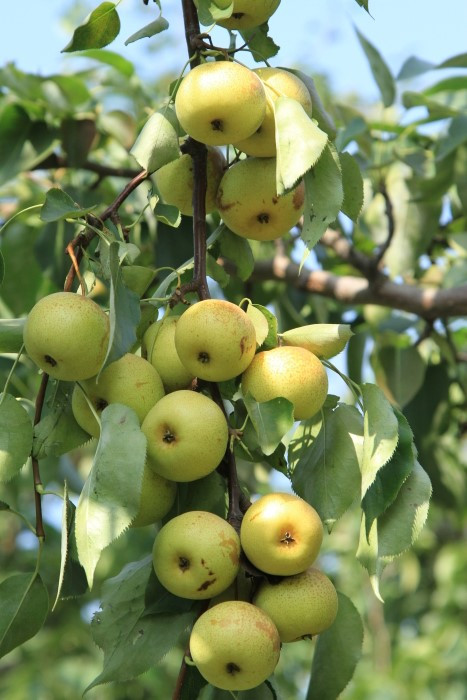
[130,107,180,173]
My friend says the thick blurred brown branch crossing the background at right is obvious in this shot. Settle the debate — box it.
[229,255,467,320]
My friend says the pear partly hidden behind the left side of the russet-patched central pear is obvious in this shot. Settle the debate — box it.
[141,316,194,393]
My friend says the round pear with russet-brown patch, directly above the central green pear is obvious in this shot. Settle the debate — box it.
[175,299,256,382]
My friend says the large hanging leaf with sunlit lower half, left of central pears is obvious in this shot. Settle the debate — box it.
[76,404,146,588]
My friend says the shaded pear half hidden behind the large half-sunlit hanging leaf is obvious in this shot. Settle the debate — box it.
[130,460,177,527]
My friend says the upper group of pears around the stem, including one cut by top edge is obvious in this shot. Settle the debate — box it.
[154,0,312,241]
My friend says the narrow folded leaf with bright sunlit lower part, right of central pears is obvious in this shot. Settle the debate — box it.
[362,384,399,498]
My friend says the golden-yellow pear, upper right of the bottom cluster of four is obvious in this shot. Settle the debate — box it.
[240,493,323,576]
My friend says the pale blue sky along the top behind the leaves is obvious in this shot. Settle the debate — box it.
[0,0,467,101]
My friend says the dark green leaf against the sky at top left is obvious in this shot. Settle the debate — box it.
[62,2,120,53]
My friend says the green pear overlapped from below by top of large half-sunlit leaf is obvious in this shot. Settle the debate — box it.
[71,353,165,437]
